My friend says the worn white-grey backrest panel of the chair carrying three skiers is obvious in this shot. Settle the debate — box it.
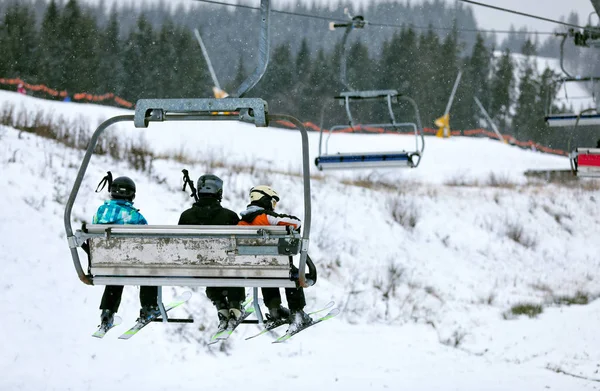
[78,225,299,287]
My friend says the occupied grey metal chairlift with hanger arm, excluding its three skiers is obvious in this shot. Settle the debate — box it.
[64,0,316,321]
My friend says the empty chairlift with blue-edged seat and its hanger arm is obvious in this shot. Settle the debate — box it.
[315,9,425,170]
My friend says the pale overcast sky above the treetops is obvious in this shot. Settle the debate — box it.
[84,0,597,31]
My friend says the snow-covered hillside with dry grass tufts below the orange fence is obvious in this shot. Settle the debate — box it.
[0,91,600,391]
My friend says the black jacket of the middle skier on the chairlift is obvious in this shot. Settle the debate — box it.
[178,198,240,225]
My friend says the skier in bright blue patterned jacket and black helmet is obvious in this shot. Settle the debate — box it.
[92,172,160,328]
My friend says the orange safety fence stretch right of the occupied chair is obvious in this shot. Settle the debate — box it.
[276,121,569,156]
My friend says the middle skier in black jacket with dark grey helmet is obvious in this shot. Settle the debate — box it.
[179,174,246,331]
